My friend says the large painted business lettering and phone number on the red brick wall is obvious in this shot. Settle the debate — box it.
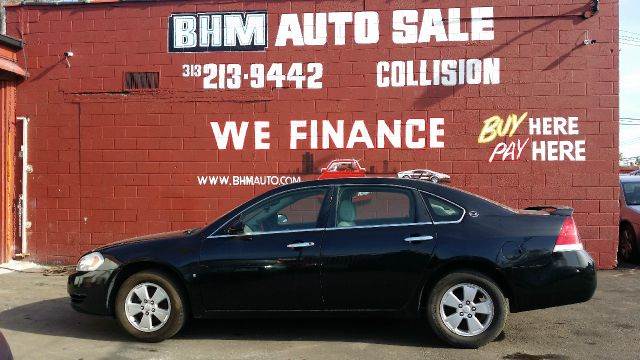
[169,7,586,162]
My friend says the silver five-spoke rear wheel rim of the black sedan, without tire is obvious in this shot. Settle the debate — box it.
[440,283,494,336]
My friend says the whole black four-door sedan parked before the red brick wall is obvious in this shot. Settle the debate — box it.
[68,178,596,348]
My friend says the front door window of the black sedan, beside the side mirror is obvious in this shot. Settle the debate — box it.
[232,188,328,235]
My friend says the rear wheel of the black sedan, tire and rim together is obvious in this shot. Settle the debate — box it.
[426,271,509,349]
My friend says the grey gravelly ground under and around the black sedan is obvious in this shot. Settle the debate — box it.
[0,267,640,360]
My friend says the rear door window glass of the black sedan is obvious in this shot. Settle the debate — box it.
[336,186,415,228]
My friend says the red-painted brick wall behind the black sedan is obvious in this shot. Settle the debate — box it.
[3,0,618,268]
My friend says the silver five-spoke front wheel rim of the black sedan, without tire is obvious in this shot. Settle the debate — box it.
[124,282,171,332]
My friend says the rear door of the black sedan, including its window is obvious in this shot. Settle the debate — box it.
[322,185,436,310]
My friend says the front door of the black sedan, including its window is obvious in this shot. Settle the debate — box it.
[198,186,331,311]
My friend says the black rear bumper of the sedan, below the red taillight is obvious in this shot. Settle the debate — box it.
[512,250,597,312]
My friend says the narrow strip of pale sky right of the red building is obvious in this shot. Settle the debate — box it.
[620,0,640,157]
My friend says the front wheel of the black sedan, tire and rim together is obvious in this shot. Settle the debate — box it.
[114,270,186,342]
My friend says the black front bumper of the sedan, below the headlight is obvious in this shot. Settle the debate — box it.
[67,270,114,315]
